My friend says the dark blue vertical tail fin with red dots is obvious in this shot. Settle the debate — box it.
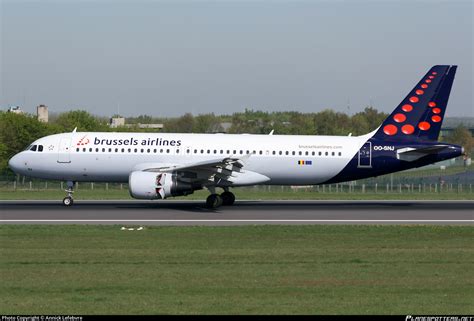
[373,66,457,140]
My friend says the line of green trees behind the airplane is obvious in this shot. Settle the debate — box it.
[0,107,474,172]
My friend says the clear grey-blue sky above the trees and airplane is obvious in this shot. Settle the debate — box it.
[0,0,474,117]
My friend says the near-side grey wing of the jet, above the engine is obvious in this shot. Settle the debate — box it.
[135,154,270,186]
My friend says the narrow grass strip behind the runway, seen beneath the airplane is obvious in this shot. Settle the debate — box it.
[0,188,474,201]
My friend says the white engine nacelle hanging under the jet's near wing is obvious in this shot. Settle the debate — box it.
[128,171,194,199]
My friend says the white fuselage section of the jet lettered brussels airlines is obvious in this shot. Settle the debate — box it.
[10,132,371,185]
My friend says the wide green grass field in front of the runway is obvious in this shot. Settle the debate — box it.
[0,225,474,315]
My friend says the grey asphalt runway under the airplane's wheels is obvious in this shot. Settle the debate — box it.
[0,200,474,226]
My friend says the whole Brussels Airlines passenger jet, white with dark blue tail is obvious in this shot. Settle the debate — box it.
[9,65,464,209]
